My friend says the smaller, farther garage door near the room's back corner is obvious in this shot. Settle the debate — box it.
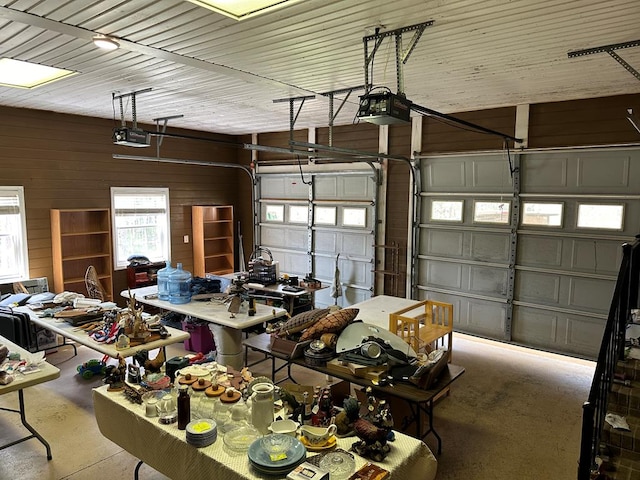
[257,168,378,307]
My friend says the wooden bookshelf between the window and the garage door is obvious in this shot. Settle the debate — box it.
[191,205,234,277]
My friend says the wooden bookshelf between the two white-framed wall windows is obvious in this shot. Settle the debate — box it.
[51,208,113,300]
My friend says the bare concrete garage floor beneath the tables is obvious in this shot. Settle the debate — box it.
[0,334,595,480]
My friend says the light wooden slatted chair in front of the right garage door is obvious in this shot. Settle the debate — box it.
[389,300,453,363]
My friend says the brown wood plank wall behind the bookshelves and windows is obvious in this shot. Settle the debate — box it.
[0,107,242,299]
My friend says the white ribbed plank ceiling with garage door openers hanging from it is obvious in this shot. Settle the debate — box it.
[0,0,640,134]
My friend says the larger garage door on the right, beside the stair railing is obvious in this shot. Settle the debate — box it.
[416,149,640,358]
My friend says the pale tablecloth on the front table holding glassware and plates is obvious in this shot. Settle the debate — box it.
[93,386,437,480]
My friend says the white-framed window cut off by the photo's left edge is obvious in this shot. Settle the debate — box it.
[0,187,29,282]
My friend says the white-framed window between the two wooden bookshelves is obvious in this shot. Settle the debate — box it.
[111,187,171,270]
